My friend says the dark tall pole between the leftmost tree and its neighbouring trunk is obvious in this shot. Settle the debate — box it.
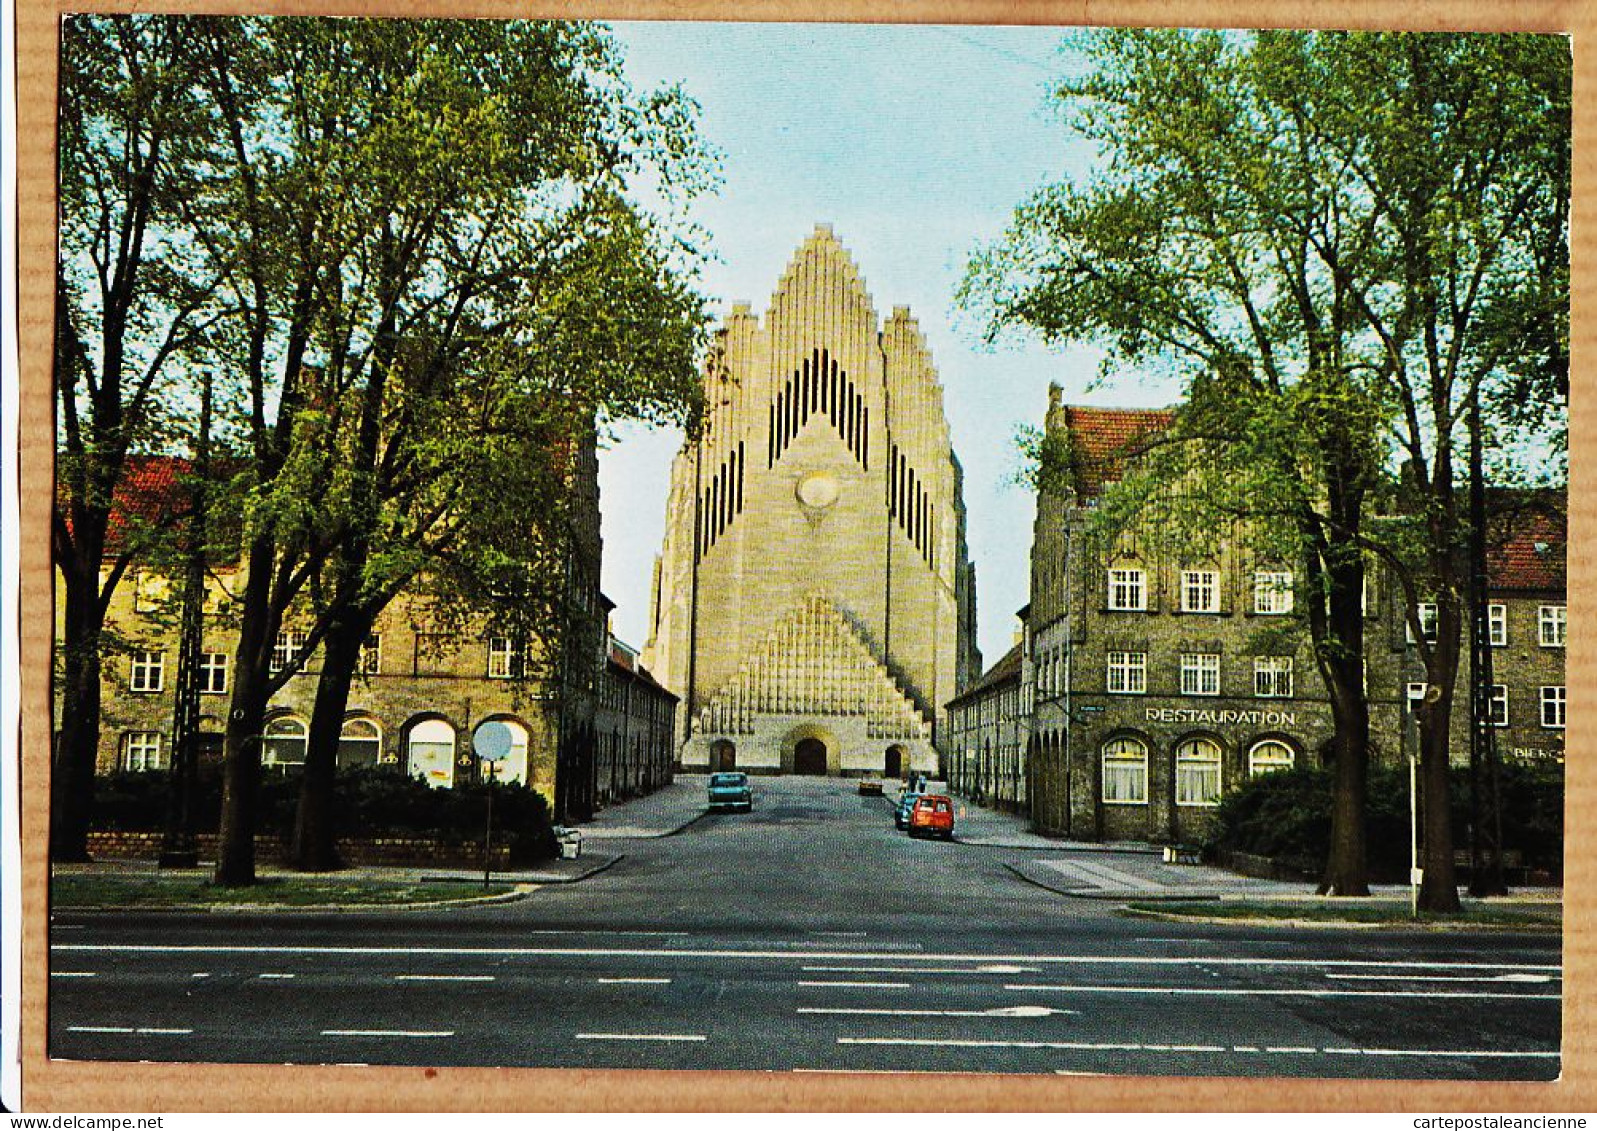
[160,371,211,867]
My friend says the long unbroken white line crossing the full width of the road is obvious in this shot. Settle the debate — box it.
[50,943,1563,973]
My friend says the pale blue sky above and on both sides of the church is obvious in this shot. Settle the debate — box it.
[600,22,1174,665]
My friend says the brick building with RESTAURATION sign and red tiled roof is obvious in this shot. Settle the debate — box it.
[1011,387,1565,842]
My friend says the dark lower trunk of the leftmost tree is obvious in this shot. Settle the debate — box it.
[50,570,104,864]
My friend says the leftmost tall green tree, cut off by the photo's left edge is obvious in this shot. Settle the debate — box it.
[50,16,219,861]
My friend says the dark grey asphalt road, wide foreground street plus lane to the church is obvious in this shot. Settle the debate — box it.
[50,778,1562,1080]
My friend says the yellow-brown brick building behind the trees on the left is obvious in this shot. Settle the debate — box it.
[56,428,676,821]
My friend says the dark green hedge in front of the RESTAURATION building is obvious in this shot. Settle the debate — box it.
[1207,762,1563,882]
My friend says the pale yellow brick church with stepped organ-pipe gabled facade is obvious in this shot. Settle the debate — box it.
[644,225,981,776]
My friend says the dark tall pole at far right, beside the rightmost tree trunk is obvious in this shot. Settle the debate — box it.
[1469,387,1508,896]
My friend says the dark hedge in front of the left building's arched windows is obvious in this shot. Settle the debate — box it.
[91,768,559,864]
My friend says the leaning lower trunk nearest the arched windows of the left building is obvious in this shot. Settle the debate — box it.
[291,618,371,872]
